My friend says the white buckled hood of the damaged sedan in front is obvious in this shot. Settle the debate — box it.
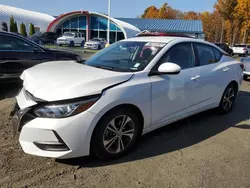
[21,61,133,101]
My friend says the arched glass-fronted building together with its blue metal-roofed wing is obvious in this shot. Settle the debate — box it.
[47,11,204,42]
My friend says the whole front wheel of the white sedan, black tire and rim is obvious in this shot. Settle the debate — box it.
[91,108,142,160]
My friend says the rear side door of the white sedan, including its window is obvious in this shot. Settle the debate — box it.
[193,43,226,106]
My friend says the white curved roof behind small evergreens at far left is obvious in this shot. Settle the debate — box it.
[0,5,55,33]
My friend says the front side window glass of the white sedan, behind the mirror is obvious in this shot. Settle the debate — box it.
[159,43,195,69]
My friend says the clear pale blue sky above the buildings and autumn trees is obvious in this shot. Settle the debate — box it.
[0,0,216,18]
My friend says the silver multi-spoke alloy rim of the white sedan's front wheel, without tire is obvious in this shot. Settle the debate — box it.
[103,115,135,154]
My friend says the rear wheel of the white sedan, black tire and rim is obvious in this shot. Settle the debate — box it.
[218,83,237,114]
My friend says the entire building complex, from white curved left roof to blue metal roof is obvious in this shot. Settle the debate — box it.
[0,5,204,42]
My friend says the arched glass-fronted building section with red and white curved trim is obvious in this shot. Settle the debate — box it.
[47,11,140,42]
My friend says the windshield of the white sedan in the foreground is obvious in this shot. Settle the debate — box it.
[85,41,166,72]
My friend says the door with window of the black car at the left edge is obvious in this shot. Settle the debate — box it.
[0,35,49,77]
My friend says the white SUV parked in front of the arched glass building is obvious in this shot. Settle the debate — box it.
[57,32,85,47]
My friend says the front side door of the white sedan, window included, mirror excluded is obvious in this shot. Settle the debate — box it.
[150,42,200,126]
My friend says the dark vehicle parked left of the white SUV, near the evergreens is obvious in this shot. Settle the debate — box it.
[29,32,58,45]
